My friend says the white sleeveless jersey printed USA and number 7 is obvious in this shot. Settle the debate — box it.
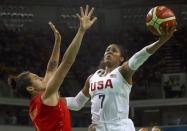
[89,67,132,124]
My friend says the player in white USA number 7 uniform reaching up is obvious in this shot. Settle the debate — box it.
[66,24,176,131]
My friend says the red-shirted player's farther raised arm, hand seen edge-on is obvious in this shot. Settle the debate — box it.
[43,21,61,84]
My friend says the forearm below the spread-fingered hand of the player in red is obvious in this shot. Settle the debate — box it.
[63,28,85,64]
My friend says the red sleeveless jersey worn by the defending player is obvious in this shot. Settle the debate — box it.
[29,94,72,131]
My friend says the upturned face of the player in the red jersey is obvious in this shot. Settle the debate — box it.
[29,73,45,91]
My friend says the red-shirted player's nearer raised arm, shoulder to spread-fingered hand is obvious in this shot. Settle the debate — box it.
[42,5,97,105]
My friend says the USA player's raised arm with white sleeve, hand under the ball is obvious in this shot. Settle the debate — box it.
[119,28,176,84]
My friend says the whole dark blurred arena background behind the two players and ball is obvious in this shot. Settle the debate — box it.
[0,0,187,131]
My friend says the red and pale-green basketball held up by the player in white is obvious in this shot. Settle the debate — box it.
[146,6,177,36]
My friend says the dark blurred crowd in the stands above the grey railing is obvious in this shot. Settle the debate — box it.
[0,23,187,99]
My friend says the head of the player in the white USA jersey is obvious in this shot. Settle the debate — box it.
[104,44,123,66]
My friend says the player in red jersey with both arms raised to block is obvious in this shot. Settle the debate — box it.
[9,6,97,131]
